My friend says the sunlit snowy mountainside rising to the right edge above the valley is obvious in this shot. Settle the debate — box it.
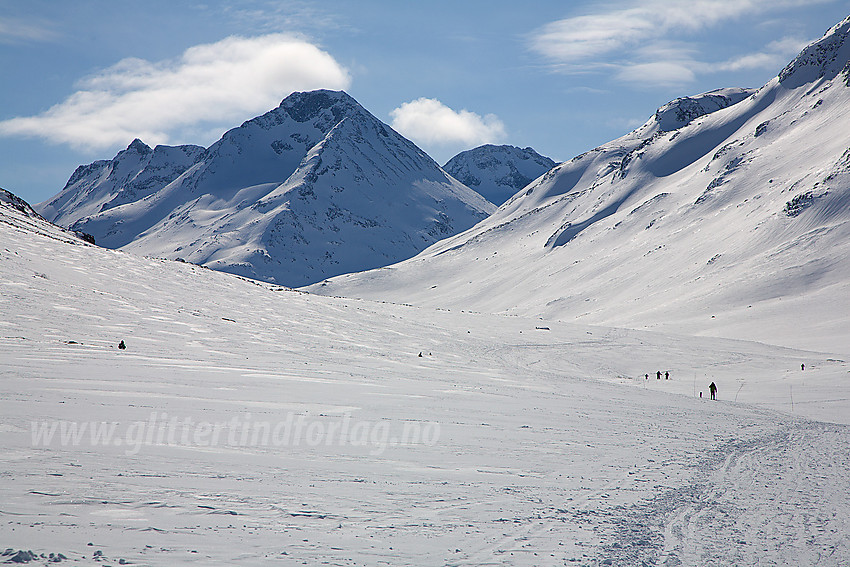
[312,19,850,352]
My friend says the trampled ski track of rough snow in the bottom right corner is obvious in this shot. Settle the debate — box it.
[602,422,850,566]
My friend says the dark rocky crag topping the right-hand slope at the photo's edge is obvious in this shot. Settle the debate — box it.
[779,16,850,89]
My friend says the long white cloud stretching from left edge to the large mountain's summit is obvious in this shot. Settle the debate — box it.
[0,34,351,149]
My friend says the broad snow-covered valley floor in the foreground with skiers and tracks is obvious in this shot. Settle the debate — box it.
[0,207,850,565]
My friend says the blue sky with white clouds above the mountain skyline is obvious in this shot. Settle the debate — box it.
[0,0,850,203]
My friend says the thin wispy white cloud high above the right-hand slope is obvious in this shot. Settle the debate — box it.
[530,0,833,86]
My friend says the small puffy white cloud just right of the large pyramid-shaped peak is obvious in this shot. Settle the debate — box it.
[390,98,506,147]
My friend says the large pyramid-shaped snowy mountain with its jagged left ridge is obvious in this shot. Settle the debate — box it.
[38,90,495,286]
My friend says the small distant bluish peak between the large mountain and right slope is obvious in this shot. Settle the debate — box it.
[443,144,555,205]
